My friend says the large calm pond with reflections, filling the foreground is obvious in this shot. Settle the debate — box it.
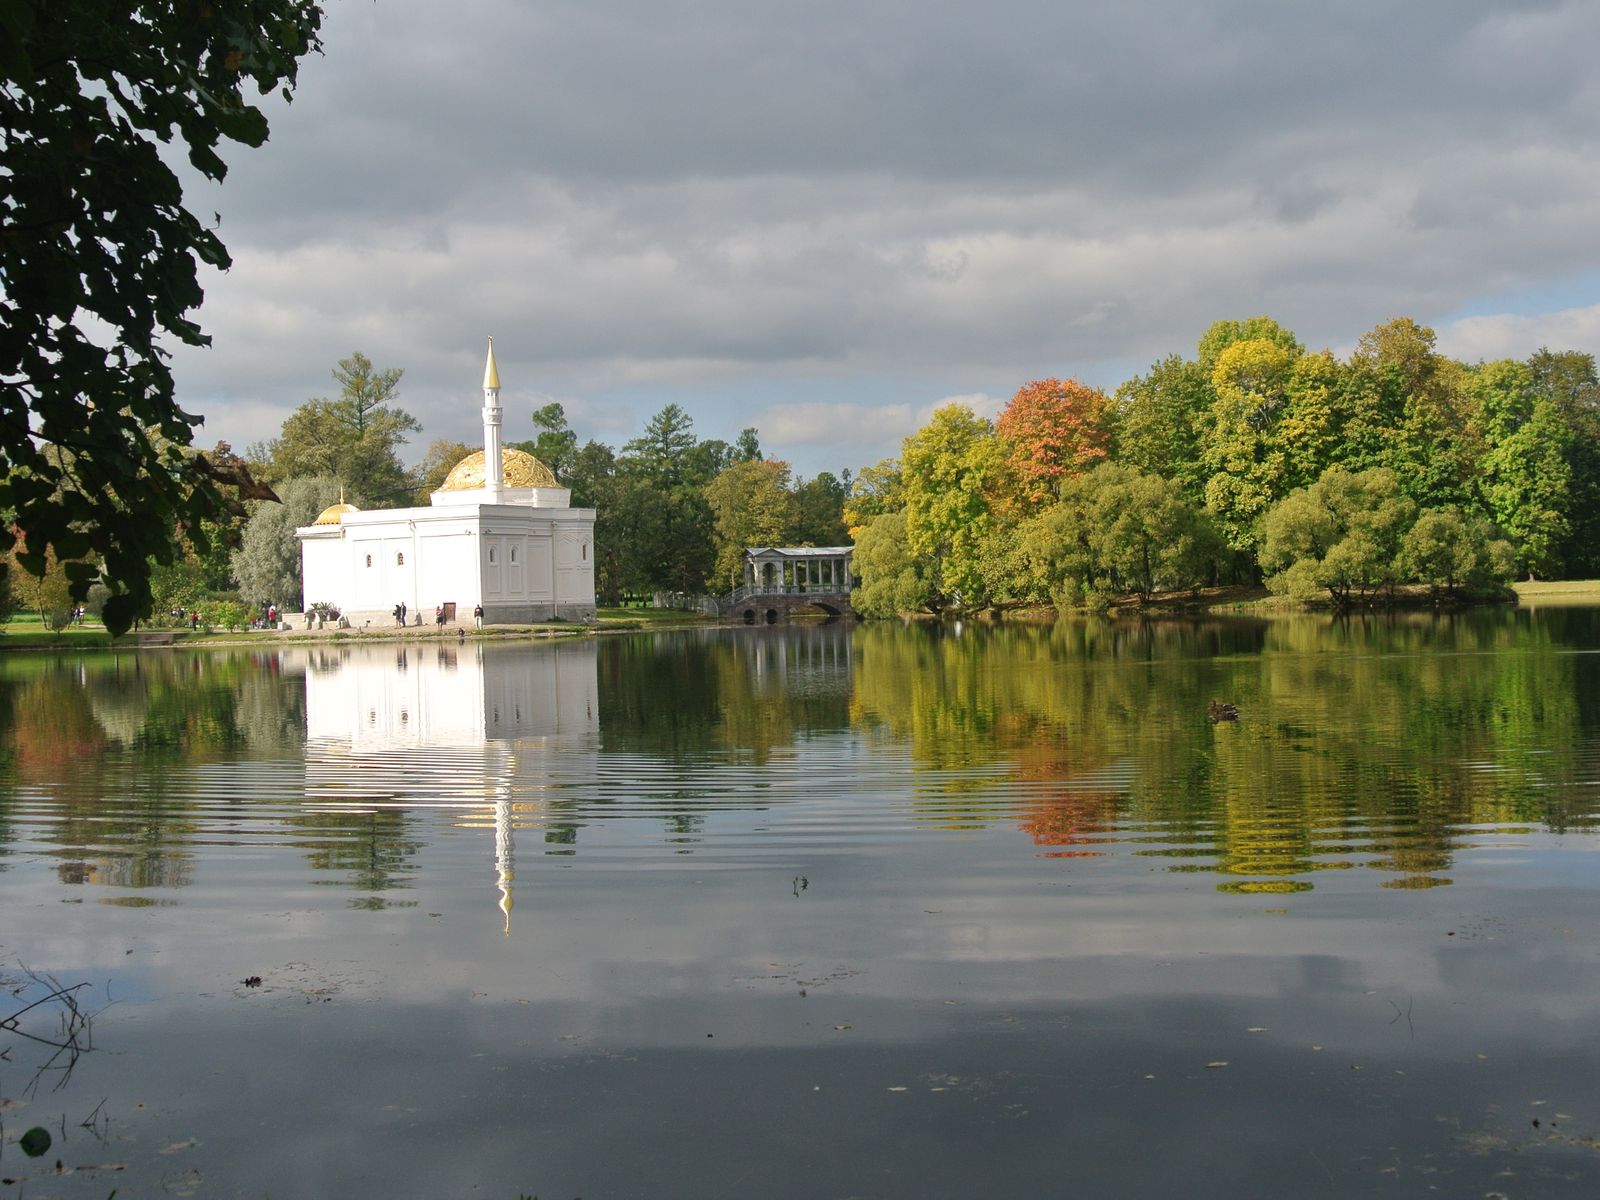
[0,608,1600,1200]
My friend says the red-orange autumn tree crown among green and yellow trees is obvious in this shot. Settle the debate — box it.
[995,379,1112,504]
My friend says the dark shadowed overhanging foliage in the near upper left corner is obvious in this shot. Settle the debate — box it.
[0,0,322,632]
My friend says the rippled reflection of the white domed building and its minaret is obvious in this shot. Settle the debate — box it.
[302,638,600,930]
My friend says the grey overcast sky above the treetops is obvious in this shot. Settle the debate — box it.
[176,0,1600,475]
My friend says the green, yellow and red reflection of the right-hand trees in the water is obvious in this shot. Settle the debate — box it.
[851,611,1600,893]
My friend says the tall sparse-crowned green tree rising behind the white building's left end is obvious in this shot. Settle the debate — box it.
[269,350,421,506]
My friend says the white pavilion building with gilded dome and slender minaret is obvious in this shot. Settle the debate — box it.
[294,338,595,626]
